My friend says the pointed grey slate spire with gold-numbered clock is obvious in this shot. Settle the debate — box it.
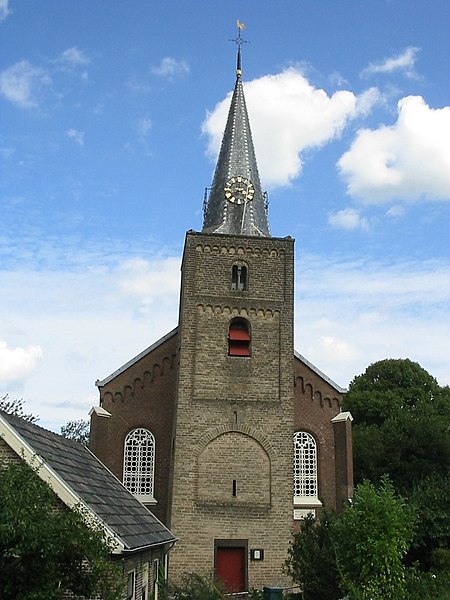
[202,44,270,237]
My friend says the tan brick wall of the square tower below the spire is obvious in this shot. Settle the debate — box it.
[171,233,293,587]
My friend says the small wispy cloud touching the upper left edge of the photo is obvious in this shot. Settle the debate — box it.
[0,60,51,108]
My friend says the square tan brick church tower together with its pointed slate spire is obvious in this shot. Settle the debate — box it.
[170,49,294,590]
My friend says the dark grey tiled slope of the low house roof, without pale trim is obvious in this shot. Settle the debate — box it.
[0,411,176,551]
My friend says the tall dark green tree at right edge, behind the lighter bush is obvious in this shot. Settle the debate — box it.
[344,359,450,569]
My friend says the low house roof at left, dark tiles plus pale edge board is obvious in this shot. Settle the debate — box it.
[0,411,176,553]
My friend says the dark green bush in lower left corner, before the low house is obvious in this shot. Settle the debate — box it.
[0,463,123,600]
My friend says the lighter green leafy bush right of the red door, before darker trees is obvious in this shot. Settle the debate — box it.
[286,478,415,600]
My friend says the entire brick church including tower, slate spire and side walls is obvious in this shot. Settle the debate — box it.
[90,47,352,591]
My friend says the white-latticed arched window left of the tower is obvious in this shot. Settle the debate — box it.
[123,428,155,502]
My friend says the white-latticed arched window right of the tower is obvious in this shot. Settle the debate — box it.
[294,431,318,503]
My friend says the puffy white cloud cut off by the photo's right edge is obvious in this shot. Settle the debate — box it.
[338,96,450,204]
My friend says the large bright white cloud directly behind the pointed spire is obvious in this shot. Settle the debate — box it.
[202,67,379,188]
